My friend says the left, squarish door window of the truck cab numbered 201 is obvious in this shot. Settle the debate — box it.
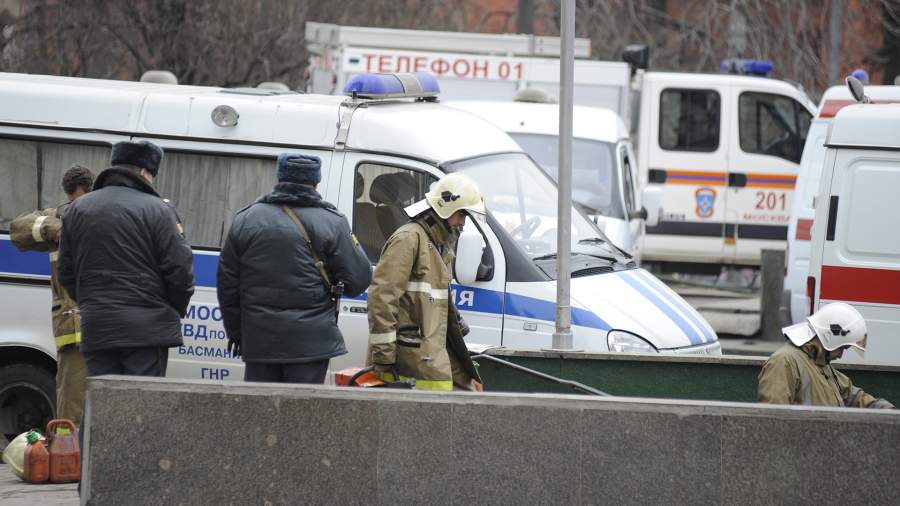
[659,89,722,152]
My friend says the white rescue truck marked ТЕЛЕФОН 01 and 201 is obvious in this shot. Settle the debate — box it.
[306,22,815,273]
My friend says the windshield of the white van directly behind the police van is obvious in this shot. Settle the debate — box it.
[509,133,625,219]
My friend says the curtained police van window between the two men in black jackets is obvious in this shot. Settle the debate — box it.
[155,154,275,248]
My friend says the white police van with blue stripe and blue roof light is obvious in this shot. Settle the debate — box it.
[0,74,721,434]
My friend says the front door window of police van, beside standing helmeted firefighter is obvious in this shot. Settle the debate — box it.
[353,163,437,264]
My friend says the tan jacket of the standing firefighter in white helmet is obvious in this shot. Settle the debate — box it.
[368,211,455,390]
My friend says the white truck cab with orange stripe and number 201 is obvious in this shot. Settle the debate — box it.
[637,72,814,266]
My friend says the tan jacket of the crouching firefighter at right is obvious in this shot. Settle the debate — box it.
[757,343,894,409]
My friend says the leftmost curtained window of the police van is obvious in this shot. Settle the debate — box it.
[0,139,110,230]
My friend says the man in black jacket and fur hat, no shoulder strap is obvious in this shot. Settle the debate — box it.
[59,141,194,376]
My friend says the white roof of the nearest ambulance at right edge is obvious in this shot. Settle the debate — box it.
[825,104,900,149]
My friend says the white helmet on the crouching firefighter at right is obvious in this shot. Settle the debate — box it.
[782,302,868,352]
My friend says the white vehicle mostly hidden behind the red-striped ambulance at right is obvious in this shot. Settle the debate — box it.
[784,82,900,322]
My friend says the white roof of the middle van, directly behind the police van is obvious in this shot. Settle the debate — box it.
[447,100,628,143]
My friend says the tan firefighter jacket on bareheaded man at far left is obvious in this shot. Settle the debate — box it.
[9,204,81,349]
